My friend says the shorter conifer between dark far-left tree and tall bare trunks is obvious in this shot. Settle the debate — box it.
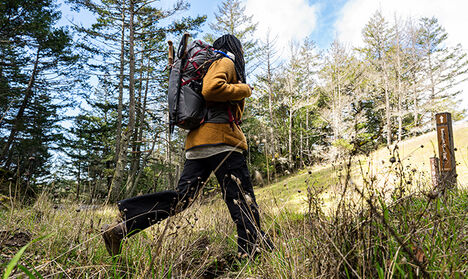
[62,83,117,202]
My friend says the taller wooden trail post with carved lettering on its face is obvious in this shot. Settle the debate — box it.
[435,112,457,191]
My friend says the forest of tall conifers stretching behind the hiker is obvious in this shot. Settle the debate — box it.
[0,0,468,203]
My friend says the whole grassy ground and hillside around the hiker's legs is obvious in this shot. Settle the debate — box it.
[0,125,468,279]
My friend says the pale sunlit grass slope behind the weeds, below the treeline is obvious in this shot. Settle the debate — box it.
[256,123,468,210]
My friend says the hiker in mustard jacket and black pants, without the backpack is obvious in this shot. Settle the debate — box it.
[103,34,271,258]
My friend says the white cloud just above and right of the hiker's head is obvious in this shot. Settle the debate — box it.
[245,0,317,54]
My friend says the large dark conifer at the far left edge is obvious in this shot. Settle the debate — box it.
[0,0,81,188]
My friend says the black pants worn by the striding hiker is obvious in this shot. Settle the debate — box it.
[118,152,263,254]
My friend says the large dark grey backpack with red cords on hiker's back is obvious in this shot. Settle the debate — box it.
[168,33,223,132]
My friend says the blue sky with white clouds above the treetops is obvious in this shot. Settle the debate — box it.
[60,0,468,112]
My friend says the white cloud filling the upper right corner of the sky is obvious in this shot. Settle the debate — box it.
[335,0,468,111]
